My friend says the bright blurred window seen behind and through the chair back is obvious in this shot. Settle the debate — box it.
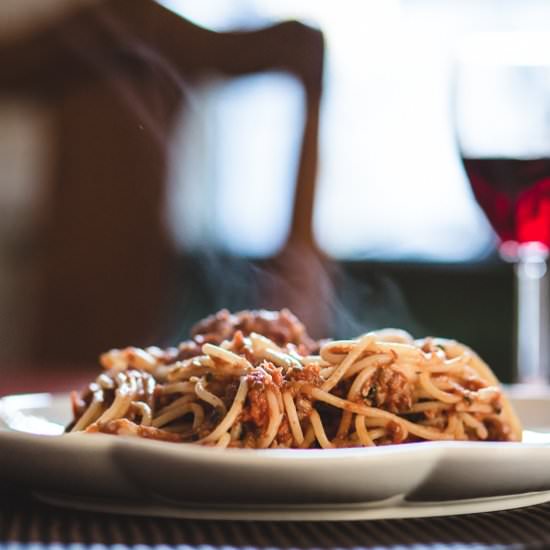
[163,0,550,261]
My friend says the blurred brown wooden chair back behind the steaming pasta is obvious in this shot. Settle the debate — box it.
[0,0,324,361]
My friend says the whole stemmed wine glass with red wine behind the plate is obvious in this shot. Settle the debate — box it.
[453,32,550,384]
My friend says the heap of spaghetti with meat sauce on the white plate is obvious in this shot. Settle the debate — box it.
[67,310,521,448]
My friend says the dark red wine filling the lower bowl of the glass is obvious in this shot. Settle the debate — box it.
[462,157,550,248]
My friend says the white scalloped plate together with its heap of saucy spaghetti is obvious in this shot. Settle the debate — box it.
[0,310,550,519]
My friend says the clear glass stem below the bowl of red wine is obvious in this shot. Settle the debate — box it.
[515,249,548,384]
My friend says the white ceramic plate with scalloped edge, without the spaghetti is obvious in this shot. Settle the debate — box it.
[0,394,550,520]
